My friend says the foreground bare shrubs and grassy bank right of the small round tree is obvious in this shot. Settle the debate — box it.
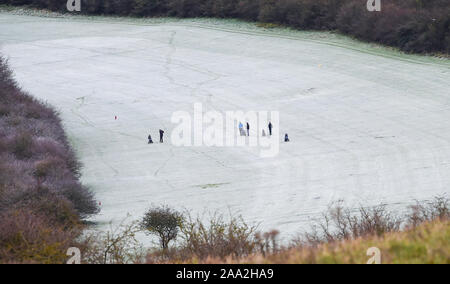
[143,197,450,264]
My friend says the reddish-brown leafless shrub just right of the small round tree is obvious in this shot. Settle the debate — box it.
[146,207,280,263]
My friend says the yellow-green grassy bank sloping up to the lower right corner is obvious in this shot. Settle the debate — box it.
[201,220,450,264]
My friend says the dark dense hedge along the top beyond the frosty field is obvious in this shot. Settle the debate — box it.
[0,0,450,53]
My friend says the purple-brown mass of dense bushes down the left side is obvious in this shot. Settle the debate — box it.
[0,57,98,263]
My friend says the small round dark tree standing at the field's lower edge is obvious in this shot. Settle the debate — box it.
[141,205,184,250]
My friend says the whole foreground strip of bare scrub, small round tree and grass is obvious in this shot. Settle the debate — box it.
[84,197,450,264]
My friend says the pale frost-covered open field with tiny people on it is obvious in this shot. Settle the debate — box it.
[0,13,450,241]
